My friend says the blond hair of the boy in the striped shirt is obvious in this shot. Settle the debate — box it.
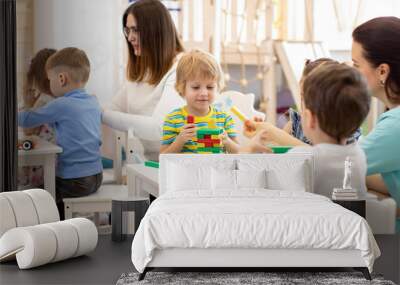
[175,50,224,96]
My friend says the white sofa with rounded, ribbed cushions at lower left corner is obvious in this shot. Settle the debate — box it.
[0,189,98,269]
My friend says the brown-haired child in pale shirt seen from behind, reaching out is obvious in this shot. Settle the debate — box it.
[252,63,370,198]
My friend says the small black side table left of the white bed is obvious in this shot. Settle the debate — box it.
[111,197,150,241]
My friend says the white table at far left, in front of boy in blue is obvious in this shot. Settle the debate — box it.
[18,137,62,199]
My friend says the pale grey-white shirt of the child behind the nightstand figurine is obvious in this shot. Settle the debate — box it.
[290,143,367,198]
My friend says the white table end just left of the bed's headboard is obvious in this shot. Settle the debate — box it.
[126,164,159,197]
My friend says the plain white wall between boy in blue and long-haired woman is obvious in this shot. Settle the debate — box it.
[33,0,127,104]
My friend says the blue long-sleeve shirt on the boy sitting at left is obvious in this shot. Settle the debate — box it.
[18,89,103,179]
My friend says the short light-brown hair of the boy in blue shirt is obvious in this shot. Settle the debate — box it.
[46,47,90,83]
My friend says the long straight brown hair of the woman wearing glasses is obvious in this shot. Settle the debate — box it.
[122,0,183,84]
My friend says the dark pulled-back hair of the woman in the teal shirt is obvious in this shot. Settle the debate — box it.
[353,17,400,104]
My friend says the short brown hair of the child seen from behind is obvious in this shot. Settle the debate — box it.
[303,62,370,142]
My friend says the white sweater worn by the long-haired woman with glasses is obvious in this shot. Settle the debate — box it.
[102,59,185,156]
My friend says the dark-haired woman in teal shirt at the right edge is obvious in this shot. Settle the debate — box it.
[352,17,400,232]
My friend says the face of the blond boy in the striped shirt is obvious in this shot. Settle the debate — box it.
[183,78,217,115]
